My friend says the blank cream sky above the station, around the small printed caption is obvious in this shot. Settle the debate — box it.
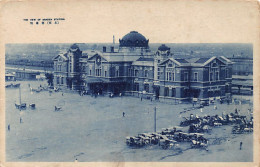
[1,0,259,43]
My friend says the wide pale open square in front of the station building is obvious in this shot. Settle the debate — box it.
[5,81,253,162]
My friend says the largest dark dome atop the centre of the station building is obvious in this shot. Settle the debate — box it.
[119,31,149,47]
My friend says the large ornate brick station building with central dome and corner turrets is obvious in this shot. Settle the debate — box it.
[53,31,232,101]
